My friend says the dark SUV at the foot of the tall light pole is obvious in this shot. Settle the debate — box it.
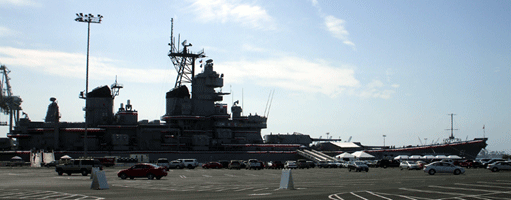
[55,159,103,176]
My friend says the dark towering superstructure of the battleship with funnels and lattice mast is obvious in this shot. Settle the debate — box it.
[8,23,274,153]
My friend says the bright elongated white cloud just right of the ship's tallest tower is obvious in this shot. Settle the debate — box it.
[215,57,359,97]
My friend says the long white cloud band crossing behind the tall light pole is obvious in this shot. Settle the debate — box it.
[0,47,169,83]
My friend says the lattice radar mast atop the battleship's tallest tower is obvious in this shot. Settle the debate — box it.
[168,18,206,88]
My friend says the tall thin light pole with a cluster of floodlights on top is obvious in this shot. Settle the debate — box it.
[75,13,103,157]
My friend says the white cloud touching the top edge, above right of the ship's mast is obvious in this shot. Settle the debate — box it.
[190,0,275,30]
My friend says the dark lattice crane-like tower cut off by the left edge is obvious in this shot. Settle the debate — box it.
[0,65,22,132]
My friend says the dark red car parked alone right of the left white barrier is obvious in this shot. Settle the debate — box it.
[117,163,167,180]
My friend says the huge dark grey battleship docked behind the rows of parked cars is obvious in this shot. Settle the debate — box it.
[0,19,487,162]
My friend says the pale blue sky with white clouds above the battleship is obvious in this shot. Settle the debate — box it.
[0,0,511,153]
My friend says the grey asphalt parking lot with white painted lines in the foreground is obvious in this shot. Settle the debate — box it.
[0,167,511,199]
